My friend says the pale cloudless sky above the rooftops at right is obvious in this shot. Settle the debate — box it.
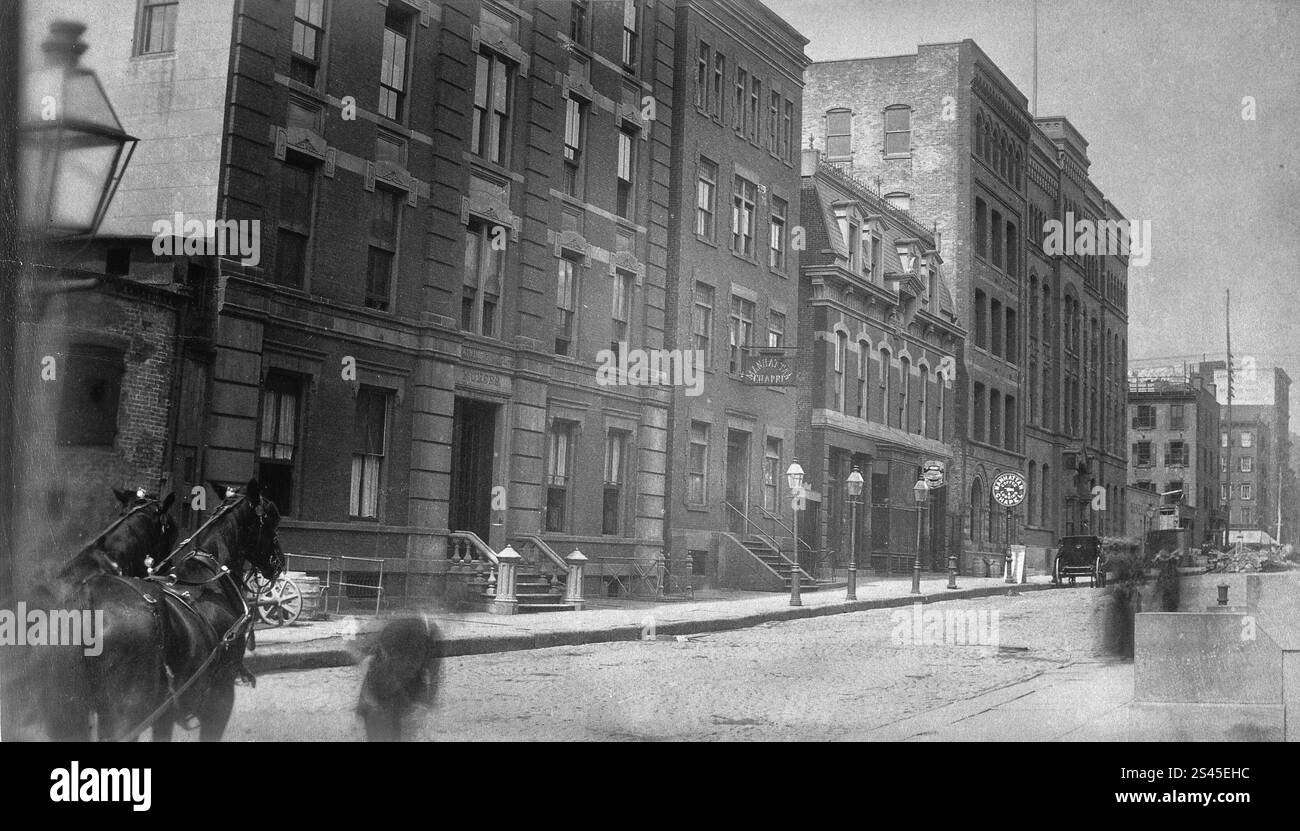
[764,0,1300,416]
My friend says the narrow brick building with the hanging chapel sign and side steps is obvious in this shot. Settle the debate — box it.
[664,0,809,584]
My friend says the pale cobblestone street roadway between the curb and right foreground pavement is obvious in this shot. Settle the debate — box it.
[205,588,1104,741]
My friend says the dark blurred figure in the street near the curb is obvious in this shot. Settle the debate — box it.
[356,616,442,741]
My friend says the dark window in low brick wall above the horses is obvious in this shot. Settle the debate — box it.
[56,346,126,447]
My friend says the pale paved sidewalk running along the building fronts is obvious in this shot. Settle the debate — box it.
[244,572,1055,672]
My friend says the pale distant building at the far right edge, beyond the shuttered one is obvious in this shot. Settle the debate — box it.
[1200,359,1291,542]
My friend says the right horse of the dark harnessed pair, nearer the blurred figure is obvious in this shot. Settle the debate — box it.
[141,480,285,741]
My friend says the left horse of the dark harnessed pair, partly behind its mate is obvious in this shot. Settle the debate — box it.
[18,492,177,741]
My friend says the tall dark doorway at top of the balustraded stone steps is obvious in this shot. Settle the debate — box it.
[447,398,501,542]
